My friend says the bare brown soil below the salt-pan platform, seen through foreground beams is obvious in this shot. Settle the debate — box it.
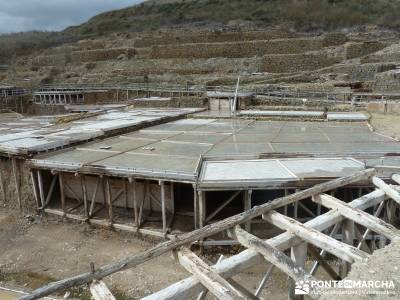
[0,208,287,300]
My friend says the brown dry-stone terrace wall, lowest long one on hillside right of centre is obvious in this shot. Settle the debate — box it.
[260,52,343,73]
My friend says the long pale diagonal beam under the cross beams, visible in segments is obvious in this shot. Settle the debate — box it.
[143,190,386,300]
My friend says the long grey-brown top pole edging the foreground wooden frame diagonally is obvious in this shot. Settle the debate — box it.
[21,169,376,300]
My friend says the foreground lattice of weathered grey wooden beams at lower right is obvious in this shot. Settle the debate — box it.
[21,169,400,300]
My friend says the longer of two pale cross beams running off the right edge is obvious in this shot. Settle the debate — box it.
[313,194,400,239]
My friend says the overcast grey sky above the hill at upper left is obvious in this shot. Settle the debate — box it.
[0,0,143,33]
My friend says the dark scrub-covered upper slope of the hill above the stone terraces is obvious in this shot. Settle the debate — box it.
[0,0,400,64]
